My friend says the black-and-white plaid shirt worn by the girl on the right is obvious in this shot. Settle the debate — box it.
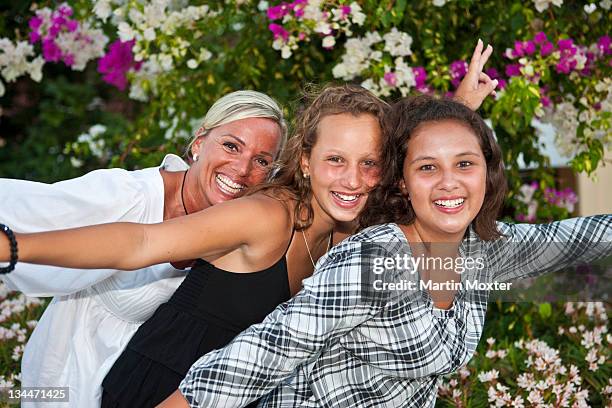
[180,215,612,408]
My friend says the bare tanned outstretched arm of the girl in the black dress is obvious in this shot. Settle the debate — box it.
[0,195,290,270]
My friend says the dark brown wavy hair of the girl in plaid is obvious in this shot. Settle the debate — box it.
[359,95,507,240]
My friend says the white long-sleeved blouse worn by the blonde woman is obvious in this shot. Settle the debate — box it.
[0,155,188,408]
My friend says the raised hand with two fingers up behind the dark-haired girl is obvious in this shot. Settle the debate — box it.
[455,39,498,110]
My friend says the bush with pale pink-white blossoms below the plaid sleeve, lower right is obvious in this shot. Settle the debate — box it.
[439,302,612,407]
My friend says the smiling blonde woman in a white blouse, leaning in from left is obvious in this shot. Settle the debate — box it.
[0,91,286,408]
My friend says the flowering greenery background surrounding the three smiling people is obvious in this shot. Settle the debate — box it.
[0,0,612,406]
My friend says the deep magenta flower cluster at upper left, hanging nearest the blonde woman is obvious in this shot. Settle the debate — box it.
[98,40,141,91]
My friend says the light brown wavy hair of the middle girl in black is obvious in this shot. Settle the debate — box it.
[249,84,389,229]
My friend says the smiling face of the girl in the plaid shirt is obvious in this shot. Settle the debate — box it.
[400,120,487,242]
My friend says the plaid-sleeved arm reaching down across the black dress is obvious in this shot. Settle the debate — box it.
[173,241,382,407]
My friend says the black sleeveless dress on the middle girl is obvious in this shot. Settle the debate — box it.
[102,255,290,408]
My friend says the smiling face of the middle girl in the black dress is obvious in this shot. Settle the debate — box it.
[302,113,382,222]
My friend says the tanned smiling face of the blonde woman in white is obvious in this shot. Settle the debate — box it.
[191,118,281,209]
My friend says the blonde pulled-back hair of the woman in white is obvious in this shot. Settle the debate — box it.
[185,91,287,161]
